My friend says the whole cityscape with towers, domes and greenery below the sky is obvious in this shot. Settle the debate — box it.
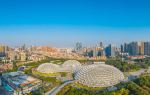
[0,41,150,95]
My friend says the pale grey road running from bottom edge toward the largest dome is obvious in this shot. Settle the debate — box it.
[45,80,74,95]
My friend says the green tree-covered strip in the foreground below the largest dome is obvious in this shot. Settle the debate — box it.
[57,75,150,95]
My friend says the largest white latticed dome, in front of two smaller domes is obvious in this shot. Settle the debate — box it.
[75,64,124,87]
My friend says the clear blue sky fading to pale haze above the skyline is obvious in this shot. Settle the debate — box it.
[0,0,150,47]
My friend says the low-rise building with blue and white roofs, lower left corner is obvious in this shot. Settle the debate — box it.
[1,72,42,95]
